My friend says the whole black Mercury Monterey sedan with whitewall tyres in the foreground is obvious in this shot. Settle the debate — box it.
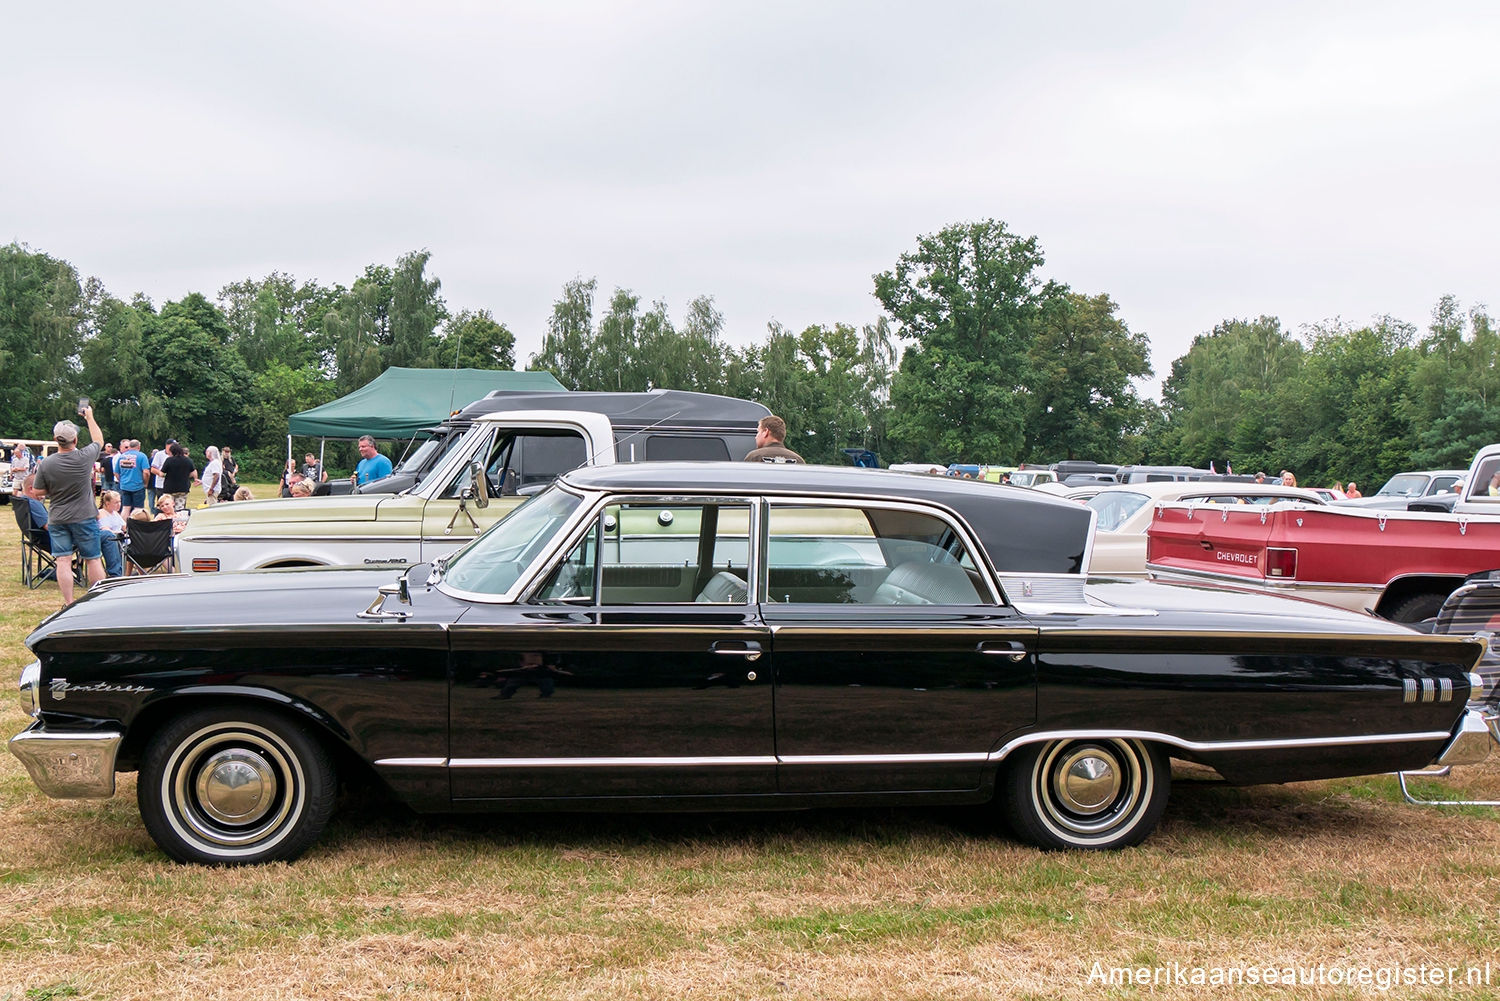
[11,464,1491,863]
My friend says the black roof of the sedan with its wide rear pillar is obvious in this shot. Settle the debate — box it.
[558,462,1094,573]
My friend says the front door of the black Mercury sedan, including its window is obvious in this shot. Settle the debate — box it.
[450,498,776,801]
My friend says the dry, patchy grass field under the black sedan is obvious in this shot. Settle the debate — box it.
[0,494,1500,1001]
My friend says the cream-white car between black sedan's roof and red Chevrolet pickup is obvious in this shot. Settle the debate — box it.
[1065,480,1323,576]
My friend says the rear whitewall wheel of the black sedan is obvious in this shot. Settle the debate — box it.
[1004,738,1172,849]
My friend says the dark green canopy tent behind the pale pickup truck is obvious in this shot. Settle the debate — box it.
[287,368,567,480]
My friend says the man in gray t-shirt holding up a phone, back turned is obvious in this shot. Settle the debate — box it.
[33,407,104,608]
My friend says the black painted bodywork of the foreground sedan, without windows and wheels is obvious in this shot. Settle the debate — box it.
[14,464,1481,852]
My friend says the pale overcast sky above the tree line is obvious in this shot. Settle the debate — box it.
[0,0,1500,392]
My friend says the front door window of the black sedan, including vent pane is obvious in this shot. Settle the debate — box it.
[534,500,752,605]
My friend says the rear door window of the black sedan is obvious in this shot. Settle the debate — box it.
[767,504,989,605]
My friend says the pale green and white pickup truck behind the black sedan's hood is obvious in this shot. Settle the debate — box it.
[177,410,618,573]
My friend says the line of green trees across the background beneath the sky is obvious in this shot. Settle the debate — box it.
[0,219,1500,483]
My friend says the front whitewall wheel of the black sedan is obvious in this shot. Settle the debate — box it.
[137,708,338,866]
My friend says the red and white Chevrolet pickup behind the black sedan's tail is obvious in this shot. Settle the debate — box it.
[1146,444,1500,621]
